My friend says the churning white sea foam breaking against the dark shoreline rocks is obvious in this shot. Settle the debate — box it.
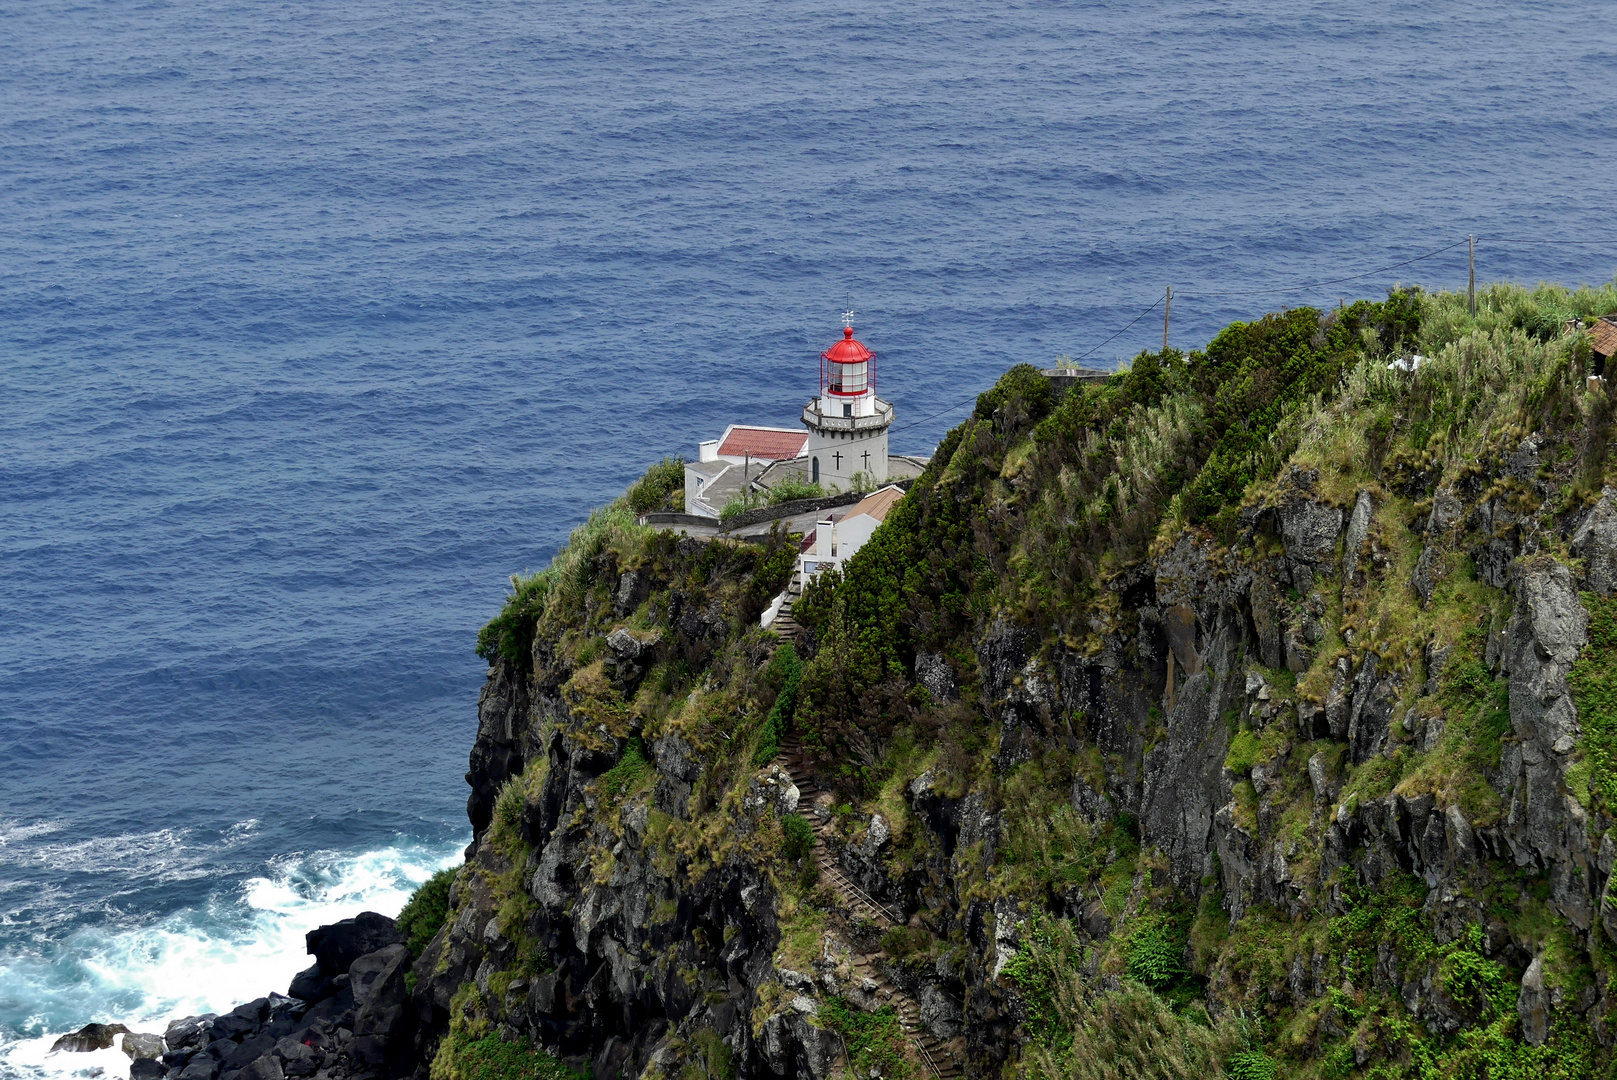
[0,837,464,1080]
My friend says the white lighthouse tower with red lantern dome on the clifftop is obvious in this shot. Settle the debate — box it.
[802,312,893,491]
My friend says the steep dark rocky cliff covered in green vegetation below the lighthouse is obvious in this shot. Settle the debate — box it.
[414,284,1617,1080]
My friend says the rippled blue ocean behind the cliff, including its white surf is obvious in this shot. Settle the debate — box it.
[0,0,1617,1075]
